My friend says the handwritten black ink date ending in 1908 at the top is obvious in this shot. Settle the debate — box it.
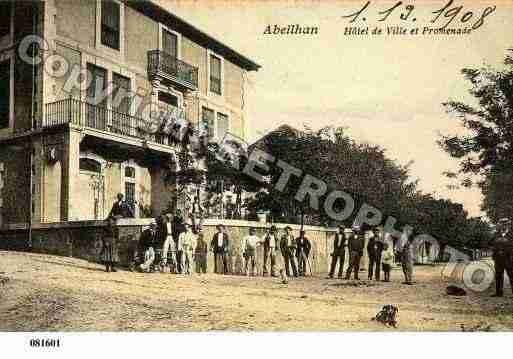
[342,0,497,30]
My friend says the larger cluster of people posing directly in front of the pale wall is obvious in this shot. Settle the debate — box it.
[131,219,311,277]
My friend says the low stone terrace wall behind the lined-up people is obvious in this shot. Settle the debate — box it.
[0,219,347,274]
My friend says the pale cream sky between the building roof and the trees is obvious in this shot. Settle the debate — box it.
[156,0,513,216]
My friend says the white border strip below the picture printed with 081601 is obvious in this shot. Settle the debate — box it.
[0,332,513,359]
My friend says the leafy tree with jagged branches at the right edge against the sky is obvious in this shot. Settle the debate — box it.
[438,50,513,221]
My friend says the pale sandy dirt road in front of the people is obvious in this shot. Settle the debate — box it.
[0,251,513,331]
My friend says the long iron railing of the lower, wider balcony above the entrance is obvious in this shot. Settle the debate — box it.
[41,98,176,144]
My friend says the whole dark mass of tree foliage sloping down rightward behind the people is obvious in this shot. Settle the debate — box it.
[251,127,490,249]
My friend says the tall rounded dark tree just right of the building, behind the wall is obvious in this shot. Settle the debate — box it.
[246,126,416,225]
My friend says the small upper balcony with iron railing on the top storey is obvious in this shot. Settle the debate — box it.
[148,50,198,91]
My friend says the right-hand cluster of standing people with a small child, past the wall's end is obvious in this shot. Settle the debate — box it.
[328,225,414,285]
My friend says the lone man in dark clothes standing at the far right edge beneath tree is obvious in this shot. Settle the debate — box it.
[493,218,513,297]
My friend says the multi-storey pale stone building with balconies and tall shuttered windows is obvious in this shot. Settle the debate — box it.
[0,0,259,227]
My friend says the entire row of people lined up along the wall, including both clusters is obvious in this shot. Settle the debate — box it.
[100,194,413,284]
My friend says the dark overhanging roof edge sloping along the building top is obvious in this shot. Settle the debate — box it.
[126,0,261,71]
